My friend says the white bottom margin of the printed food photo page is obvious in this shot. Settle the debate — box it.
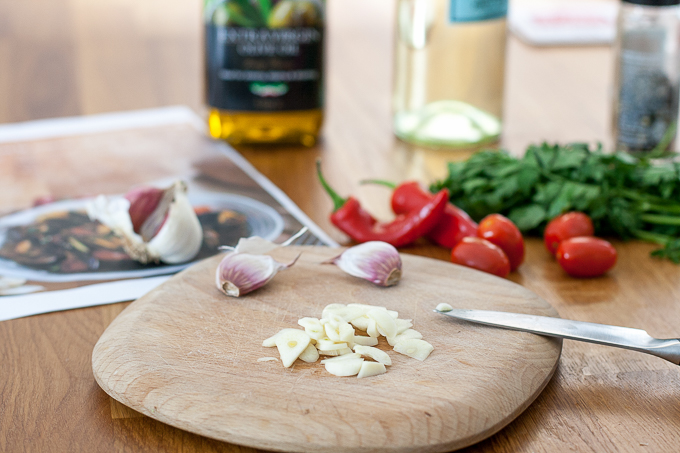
[0,275,171,321]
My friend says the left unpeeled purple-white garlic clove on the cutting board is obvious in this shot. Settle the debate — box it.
[215,252,300,297]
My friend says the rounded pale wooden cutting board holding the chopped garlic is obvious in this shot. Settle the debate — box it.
[92,247,561,452]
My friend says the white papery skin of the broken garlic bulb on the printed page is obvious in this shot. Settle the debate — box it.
[87,181,203,264]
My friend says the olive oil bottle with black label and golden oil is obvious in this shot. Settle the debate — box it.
[204,0,325,146]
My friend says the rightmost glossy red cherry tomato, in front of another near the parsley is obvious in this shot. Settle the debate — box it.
[556,236,617,278]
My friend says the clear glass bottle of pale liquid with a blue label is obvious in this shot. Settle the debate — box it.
[393,0,508,148]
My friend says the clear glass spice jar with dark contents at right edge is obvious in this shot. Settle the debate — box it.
[614,0,680,154]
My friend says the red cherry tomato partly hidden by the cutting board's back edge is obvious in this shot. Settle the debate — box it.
[451,237,510,277]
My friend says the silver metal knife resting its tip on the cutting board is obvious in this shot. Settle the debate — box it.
[434,308,680,365]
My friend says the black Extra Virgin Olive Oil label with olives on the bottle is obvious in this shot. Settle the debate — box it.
[205,0,324,111]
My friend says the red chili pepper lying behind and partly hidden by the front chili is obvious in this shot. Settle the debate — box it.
[364,180,478,248]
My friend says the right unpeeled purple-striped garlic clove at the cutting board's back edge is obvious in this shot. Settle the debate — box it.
[329,241,401,286]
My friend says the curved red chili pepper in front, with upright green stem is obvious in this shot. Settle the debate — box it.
[317,162,449,247]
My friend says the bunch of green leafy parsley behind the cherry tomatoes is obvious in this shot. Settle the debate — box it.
[431,143,680,263]
